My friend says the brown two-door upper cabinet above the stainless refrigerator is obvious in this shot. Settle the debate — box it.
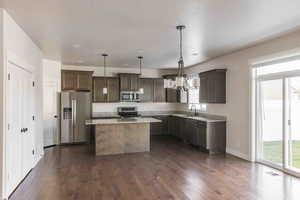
[61,70,93,91]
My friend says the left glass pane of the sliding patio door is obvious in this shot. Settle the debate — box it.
[258,79,283,166]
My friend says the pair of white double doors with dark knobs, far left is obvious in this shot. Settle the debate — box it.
[5,63,34,194]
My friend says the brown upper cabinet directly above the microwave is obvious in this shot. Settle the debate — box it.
[119,74,139,91]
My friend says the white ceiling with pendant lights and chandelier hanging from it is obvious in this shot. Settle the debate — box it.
[4,0,300,68]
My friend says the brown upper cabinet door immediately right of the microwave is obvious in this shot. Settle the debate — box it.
[139,78,154,102]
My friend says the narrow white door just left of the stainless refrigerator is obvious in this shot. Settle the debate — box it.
[43,82,59,147]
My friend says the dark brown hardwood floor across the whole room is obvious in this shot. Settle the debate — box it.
[10,137,300,200]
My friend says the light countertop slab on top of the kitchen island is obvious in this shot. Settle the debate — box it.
[85,117,161,125]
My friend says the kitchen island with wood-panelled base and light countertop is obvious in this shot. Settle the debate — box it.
[86,117,161,156]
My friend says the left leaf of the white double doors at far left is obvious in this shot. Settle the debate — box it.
[6,63,23,194]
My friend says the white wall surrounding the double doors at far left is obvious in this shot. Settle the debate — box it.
[0,10,43,196]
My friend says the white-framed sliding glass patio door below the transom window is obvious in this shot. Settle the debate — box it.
[256,73,300,173]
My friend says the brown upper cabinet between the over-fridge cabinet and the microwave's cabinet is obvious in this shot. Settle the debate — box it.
[93,77,120,103]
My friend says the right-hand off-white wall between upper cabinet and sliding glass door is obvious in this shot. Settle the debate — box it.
[176,31,300,159]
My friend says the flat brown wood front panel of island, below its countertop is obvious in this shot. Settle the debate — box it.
[95,123,150,155]
